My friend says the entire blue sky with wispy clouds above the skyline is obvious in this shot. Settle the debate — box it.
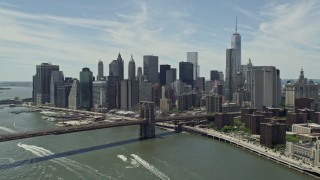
[0,0,320,81]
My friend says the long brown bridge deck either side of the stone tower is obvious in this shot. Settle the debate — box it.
[0,115,208,142]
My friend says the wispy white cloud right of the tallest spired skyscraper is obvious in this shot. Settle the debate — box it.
[242,1,320,78]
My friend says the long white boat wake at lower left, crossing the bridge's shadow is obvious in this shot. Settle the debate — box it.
[17,143,113,179]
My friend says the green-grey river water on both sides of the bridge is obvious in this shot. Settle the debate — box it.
[0,88,313,180]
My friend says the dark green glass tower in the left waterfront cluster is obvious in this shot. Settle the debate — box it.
[80,67,93,110]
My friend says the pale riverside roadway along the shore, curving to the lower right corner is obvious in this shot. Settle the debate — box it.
[182,126,320,179]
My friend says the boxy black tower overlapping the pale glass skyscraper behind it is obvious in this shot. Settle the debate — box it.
[179,62,194,86]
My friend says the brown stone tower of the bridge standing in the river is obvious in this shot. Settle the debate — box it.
[140,101,156,139]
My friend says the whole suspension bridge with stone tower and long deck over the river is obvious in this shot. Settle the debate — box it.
[0,102,213,142]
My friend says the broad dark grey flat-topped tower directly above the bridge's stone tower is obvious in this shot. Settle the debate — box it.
[143,55,159,84]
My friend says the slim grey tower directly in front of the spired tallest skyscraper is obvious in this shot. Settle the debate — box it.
[224,49,237,101]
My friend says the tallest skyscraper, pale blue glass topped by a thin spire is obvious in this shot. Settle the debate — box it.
[231,18,241,71]
